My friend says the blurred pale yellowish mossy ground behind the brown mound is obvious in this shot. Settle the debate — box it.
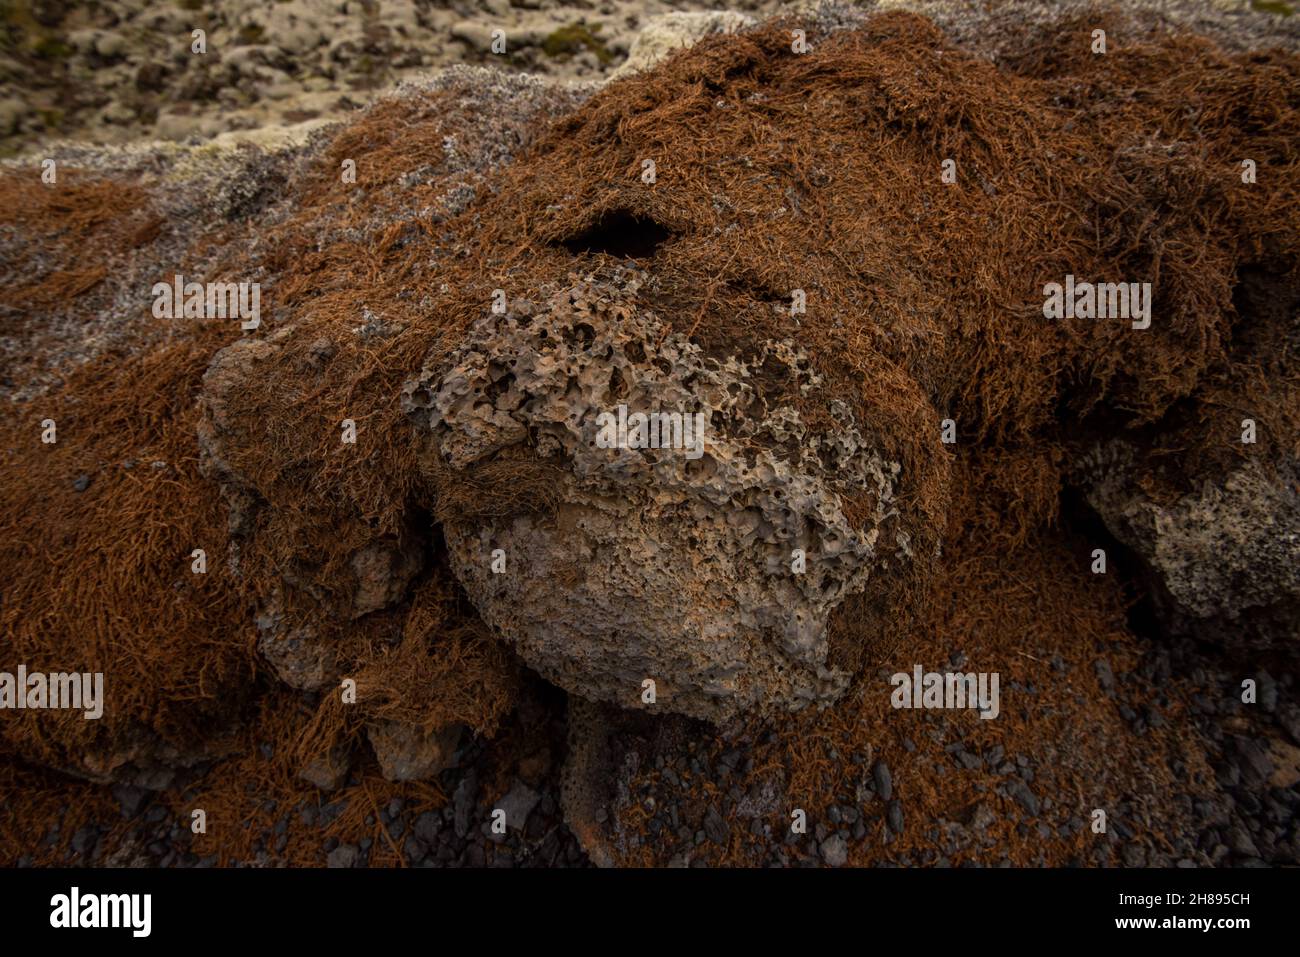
[0,0,800,156]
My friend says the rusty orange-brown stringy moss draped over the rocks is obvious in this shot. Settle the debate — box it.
[0,3,1300,862]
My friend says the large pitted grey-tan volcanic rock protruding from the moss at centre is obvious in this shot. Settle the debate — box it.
[403,270,907,720]
